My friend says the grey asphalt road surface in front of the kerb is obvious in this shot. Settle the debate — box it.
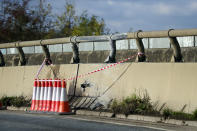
[0,111,196,131]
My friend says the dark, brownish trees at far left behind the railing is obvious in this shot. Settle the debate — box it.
[0,0,54,42]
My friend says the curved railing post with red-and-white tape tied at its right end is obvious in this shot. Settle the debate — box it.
[136,30,146,62]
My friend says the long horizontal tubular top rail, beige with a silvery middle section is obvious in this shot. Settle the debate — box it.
[0,29,197,49]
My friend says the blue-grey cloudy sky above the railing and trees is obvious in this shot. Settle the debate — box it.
[48,0,197,33]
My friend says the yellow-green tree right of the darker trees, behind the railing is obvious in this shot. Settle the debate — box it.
[57,2,109,37]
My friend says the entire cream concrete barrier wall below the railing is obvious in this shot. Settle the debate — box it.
[0,63,197,112]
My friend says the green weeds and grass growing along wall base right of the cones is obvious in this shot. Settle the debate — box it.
[110,92,197,120]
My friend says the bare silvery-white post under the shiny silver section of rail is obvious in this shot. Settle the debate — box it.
[105,35,116,63]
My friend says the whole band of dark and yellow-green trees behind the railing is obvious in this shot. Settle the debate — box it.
[0,0,109,43]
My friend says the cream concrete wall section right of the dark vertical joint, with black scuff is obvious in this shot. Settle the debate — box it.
[77,63,197,112]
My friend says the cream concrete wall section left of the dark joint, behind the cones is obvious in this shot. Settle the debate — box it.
[0,64,77,97]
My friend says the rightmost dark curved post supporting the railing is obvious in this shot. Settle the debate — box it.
[168,29,183,62]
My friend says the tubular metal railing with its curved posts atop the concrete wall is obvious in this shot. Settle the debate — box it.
[0,29,197,66]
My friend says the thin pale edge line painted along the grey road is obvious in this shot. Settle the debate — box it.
[65,116,174,131]
